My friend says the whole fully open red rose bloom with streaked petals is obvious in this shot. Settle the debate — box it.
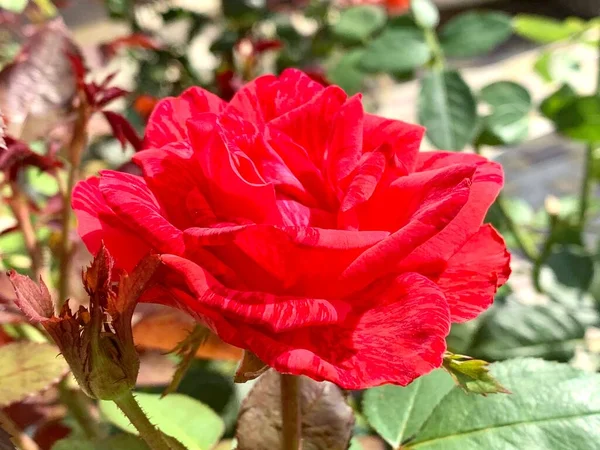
[73,70,509,388]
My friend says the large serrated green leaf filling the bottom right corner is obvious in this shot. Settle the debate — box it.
[406,359,600,450]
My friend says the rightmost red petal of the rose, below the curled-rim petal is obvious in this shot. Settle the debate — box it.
[436,225,510,322]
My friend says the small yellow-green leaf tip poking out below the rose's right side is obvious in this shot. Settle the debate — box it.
[443,352,510,396]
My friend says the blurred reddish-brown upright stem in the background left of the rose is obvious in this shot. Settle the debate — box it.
[58,93,90,308]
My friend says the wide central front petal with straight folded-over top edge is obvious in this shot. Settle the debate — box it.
[185,225,389,295]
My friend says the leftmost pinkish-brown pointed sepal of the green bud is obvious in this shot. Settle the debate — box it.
[8,270,54,322]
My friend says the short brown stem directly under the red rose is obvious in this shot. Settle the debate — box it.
[281,374,301,450]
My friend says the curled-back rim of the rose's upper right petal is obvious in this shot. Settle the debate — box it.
[402,152,504,272]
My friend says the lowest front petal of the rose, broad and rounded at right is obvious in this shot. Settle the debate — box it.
[164,273,450,389]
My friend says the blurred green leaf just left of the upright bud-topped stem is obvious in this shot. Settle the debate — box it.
[360,27,431,72]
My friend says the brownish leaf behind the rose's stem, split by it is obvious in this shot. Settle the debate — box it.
[236,370,354,450]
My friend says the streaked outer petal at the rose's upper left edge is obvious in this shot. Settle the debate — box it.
[144,87,227,148]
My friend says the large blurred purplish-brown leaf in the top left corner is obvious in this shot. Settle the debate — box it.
[0,18,79,140]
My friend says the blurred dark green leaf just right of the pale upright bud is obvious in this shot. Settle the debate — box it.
[440,12,512,58]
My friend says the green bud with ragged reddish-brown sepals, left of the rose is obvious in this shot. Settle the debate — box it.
[9,246,160,400]
